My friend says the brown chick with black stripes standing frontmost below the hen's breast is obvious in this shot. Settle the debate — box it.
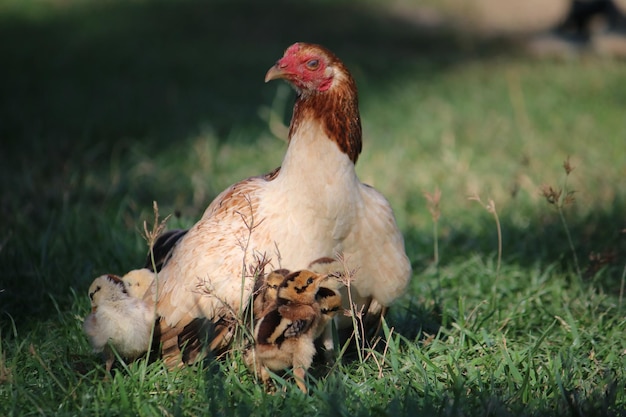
[246,270,328,393]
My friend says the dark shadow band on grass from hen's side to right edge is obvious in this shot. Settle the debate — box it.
[404,197,626,295]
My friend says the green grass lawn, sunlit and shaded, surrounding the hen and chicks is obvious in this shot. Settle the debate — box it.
[0,0,626,416]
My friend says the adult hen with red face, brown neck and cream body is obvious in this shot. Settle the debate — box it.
[146,43,411,366]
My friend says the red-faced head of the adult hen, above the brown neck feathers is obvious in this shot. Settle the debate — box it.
[265,42,349,94]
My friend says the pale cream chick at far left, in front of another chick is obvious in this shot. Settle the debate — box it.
[83,274,154,373]
